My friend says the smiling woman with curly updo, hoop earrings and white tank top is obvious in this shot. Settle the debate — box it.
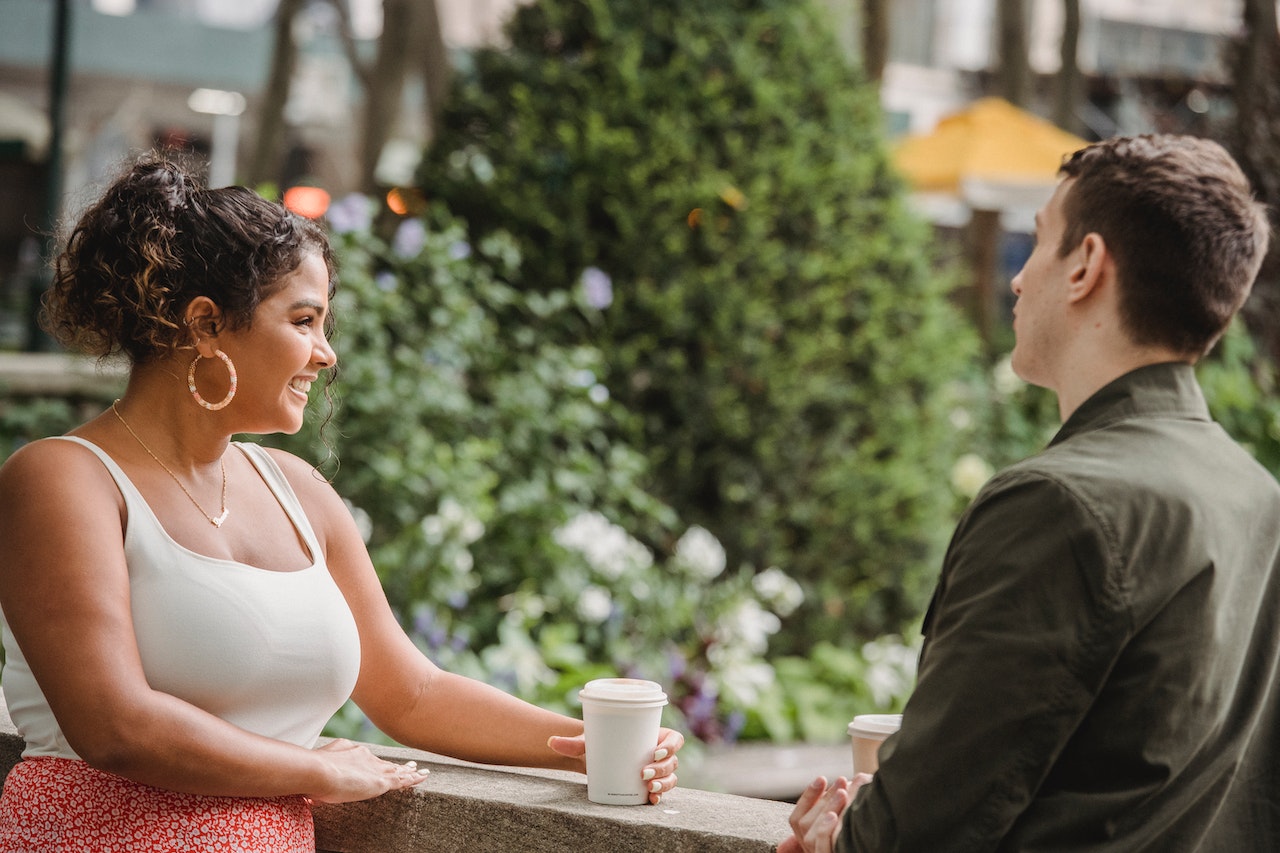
[0,158,684,853]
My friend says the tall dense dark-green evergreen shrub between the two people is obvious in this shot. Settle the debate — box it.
[420,0,977,652]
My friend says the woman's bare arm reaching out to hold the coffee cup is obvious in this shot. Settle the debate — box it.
[275,453,684,800]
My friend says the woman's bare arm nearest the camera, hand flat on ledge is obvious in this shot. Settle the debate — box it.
[0,441,421,802]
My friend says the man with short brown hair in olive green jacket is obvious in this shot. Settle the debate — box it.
[780,136,1280,853]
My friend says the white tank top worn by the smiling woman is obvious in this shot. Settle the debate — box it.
[0,437,360,758]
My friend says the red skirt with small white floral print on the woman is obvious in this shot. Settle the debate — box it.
[0,758,316,853]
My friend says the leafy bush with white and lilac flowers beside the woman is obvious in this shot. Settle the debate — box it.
[268,202,800,740]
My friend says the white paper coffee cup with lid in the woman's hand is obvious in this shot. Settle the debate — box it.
[577,679,667,806]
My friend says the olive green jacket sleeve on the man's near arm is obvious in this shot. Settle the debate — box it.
[838,471,1129,853]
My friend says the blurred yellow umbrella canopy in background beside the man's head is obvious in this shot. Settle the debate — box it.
[893,97,1088,193]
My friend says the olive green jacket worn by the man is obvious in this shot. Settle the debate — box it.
[838,364,1280,853]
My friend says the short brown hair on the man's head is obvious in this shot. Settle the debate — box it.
[1060,134,1270,357]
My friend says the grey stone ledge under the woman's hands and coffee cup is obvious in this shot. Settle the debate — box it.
[0,706,791,853]
